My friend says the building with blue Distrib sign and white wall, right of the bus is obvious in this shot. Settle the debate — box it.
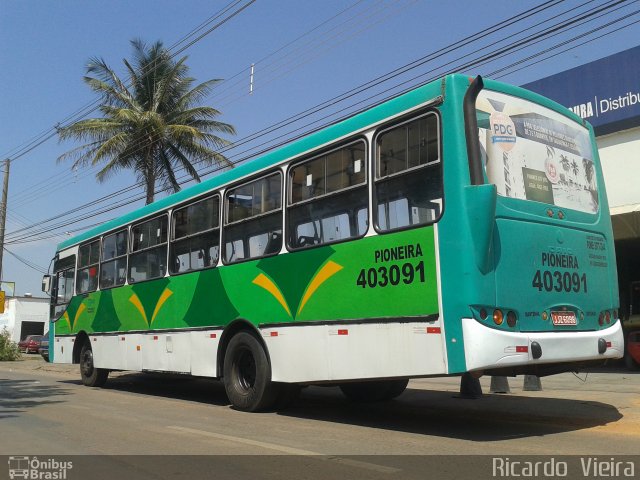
[523,46,640,334]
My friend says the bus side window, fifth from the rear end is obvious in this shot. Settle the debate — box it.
[129,215,167,283]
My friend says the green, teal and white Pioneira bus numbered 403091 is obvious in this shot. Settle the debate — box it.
[44,75,623,411]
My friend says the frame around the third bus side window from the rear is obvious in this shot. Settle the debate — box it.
[219,170,286,265]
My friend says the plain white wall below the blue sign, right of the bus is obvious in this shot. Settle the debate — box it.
[596,128,640,208]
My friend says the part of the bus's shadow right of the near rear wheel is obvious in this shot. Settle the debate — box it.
[278,387,622,442]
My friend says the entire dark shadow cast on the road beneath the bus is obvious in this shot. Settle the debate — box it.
[61,373,622,442]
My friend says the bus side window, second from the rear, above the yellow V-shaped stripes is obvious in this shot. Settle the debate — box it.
[287,141,369,249]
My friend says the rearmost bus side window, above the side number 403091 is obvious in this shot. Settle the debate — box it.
[375,113,442,231]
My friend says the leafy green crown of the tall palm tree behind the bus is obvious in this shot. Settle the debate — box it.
[58,40,235,204]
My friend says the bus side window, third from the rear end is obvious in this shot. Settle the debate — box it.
[223,172,282,263]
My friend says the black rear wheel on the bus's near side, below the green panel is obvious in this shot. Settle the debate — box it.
[223,332,279,412]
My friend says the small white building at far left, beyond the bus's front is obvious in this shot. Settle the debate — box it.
[0,296,49,342]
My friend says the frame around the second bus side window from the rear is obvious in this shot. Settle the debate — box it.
[284,135,371,252]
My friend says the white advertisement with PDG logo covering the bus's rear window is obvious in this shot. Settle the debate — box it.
[476,90,598,213]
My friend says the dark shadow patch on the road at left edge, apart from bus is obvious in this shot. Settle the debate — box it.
[0,378,69,420]
